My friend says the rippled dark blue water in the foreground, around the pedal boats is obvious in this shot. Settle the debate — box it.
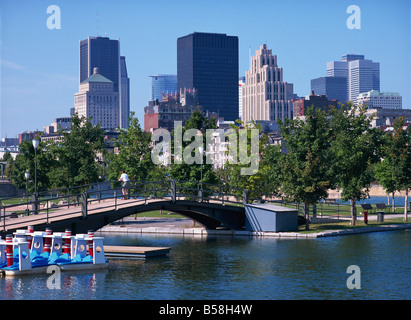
[0,230,411,300]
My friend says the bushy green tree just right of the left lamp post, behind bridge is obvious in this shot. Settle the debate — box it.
[49,114,105,192]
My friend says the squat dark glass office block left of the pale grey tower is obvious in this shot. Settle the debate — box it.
[311,77,348,103]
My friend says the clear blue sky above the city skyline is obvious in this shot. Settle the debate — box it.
[0,0,411,137]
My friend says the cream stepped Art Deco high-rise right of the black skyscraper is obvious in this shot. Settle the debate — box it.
[241,44,293,122]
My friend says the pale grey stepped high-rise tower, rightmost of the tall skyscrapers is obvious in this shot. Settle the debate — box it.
[327,54,380,104]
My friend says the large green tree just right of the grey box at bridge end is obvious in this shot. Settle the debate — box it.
[279,107,333,229]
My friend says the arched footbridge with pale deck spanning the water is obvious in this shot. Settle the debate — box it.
[2,180,254,234]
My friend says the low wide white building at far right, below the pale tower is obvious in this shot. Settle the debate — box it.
[357,90,402,109]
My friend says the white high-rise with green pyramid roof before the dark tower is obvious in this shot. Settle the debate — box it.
[74,68,120,129]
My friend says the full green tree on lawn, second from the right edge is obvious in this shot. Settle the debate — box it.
[331,103,381,225]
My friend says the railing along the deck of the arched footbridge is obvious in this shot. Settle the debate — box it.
[0,179,270,230]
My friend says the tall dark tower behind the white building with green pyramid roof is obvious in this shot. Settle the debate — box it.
[79,36,130,128]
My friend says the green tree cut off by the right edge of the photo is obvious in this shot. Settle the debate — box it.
[377,117,411,221]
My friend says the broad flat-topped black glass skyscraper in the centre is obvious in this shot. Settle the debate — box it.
[177,32,239,120]
